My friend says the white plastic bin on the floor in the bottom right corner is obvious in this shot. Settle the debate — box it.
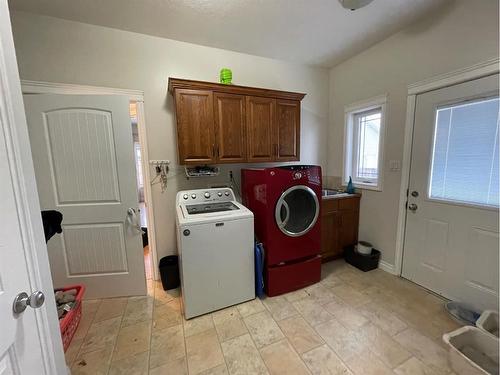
[443,326,498,375]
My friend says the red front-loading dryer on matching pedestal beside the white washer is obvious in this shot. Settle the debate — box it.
[241,165,321,296]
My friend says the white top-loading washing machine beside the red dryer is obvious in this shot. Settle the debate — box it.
[176,188,255,319]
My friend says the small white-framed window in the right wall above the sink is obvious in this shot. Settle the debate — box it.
[344,97,386,190]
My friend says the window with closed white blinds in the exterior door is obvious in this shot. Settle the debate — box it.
[428,97,499,207]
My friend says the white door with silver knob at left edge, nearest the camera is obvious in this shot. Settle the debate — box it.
[0,0,67,375]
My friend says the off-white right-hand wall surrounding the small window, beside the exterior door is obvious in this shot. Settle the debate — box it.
[327,0,498,270]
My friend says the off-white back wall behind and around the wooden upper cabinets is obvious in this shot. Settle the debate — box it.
[12,12,329,264]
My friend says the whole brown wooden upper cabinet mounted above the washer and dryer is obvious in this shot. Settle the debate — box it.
[168,78,305,165]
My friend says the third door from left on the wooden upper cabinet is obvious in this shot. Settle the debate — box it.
[246,96,277,162]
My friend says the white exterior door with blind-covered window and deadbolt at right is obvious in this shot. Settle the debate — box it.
[403,74,499,309]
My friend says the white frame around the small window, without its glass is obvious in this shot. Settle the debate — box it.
[342,95,387,191]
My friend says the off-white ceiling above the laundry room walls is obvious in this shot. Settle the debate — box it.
[10,0,451,67]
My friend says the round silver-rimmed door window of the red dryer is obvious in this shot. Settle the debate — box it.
[274,185,319,237]
